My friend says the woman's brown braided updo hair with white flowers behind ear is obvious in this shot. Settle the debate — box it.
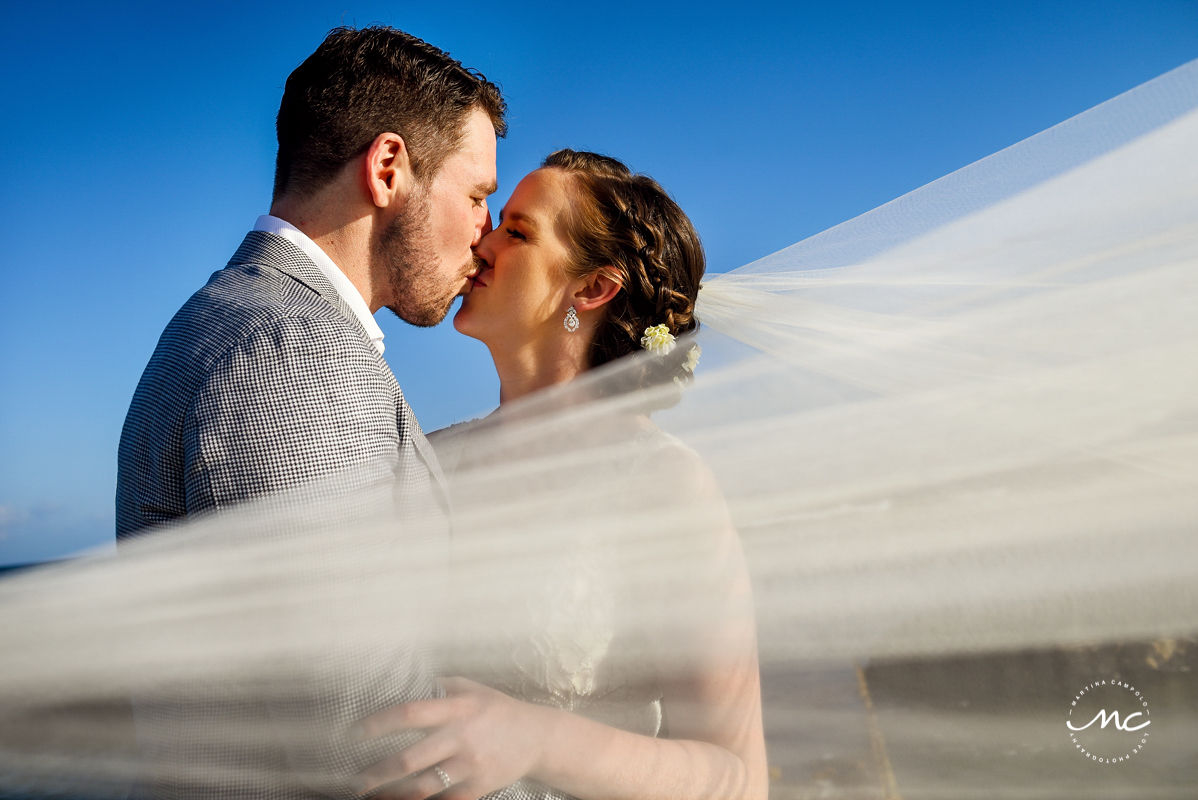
[541,150,706,366]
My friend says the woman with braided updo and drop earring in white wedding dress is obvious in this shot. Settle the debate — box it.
[352,150,768,800]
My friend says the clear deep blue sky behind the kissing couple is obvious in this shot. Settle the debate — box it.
[0,0,1198,564]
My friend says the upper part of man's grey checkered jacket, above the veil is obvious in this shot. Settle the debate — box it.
[116,231,443,538]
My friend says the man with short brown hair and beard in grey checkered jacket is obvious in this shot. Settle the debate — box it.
[116,28,539,799]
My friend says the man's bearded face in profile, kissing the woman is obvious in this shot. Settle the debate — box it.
[375,109,496,326]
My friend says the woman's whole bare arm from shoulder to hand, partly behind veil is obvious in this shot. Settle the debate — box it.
[361,450,768,800]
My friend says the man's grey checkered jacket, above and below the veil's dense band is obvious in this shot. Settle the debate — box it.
[116,231,552,800]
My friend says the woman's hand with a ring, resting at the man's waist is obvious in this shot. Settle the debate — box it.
[356,678,552,800]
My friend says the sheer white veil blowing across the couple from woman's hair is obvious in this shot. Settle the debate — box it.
[0,62,1198,798]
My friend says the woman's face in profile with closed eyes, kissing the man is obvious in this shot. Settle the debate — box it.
[453,168,574,352]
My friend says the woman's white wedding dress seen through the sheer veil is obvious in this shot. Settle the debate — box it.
[429,423,714,737]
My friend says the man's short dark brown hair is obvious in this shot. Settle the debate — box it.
[274,26,507,199]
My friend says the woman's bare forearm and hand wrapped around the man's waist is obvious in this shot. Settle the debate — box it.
[358,656,767,800]
